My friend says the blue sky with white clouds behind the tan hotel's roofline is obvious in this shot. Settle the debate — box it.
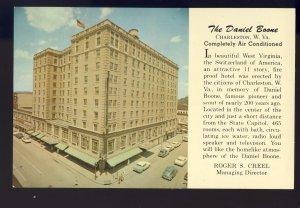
[14,7,189,98]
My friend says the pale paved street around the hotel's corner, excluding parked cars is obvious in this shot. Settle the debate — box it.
[13,135,188,188]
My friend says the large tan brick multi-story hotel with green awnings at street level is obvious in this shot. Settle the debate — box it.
[31,20,178,169]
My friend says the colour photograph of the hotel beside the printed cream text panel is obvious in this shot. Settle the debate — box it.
[12,7,189,189]
